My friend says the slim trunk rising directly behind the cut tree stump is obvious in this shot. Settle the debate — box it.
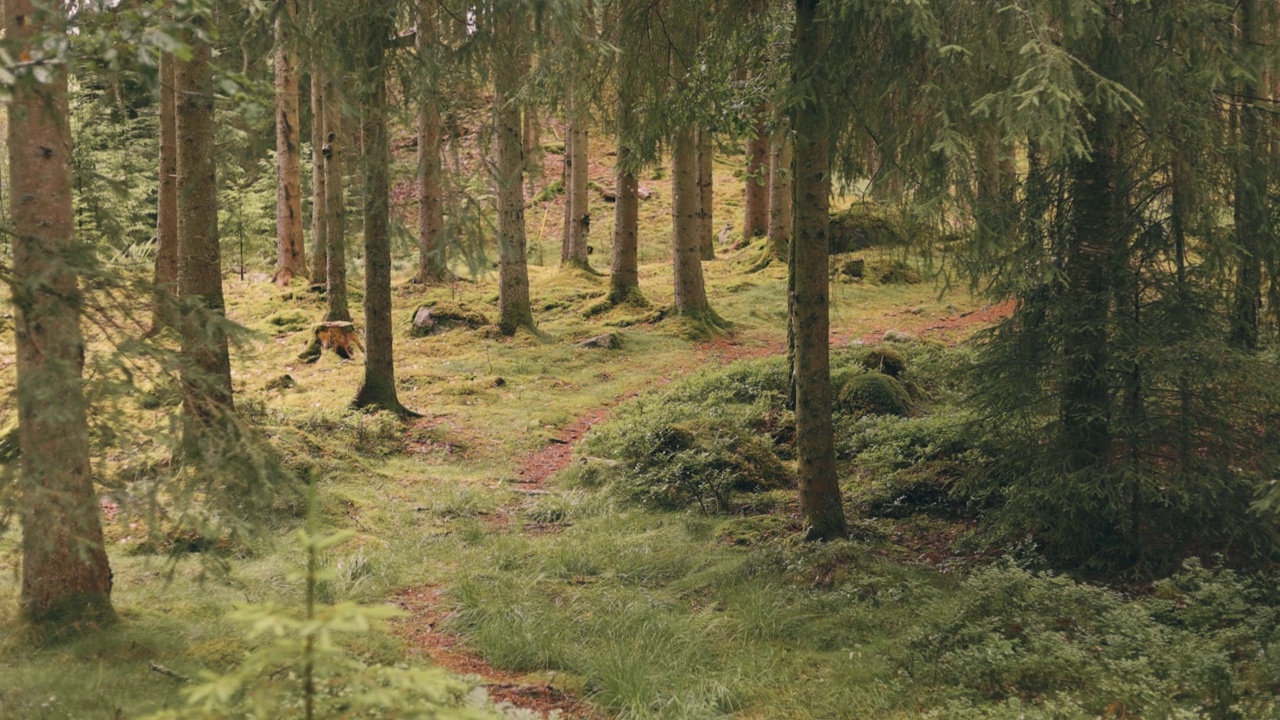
[320,79,351,323]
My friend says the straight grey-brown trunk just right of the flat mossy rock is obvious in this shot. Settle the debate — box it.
[493,12,534,334]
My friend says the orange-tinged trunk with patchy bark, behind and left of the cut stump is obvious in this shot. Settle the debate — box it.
[275,0,307,286]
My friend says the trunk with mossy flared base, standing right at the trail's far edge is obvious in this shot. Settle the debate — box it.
[671,128,712,320]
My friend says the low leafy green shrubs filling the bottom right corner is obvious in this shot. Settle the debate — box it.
[902,562,1280,717]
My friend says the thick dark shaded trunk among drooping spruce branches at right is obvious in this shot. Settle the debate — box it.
[1060,110,1121,473]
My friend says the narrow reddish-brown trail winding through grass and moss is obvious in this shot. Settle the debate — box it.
[393,302,1014,720]
